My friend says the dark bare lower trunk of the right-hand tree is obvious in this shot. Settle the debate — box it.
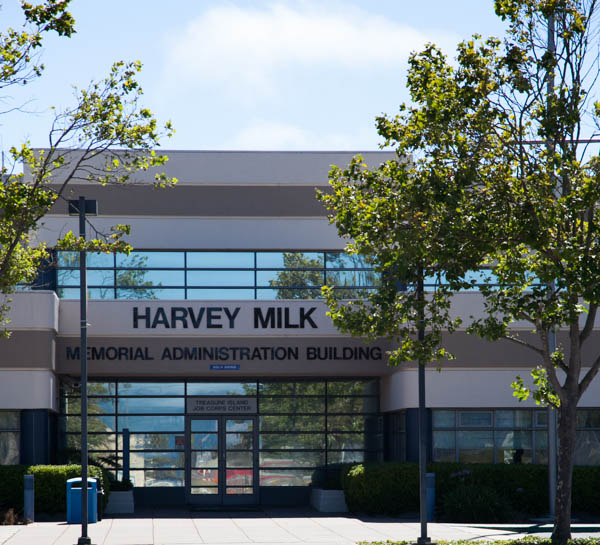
[552,402,577,544]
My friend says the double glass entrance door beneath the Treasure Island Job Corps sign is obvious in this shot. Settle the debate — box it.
[186,416,258,505]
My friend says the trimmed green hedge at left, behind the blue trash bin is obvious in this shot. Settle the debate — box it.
[0,464,110,513]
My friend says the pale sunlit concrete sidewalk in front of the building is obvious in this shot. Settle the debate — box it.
[0,509,600,545]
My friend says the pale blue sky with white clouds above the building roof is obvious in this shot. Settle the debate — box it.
[0,0,503,154]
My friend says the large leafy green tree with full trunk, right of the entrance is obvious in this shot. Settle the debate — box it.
[320,0,600,543]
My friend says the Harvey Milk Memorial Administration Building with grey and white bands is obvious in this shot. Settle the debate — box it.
[0,152,600,505]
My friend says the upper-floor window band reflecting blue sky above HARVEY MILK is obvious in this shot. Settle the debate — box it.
[56,251,379,299]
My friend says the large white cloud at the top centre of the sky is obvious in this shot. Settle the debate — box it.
[165,1,456,104]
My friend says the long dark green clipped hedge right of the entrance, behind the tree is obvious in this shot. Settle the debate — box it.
[341,462,600,522]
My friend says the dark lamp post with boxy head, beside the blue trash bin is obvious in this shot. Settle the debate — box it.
[69,197,98,545]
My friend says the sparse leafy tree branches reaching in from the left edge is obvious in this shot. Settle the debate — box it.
[0,0,176,323]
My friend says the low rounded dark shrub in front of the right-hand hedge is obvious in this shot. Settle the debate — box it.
[442,484,512,522]
